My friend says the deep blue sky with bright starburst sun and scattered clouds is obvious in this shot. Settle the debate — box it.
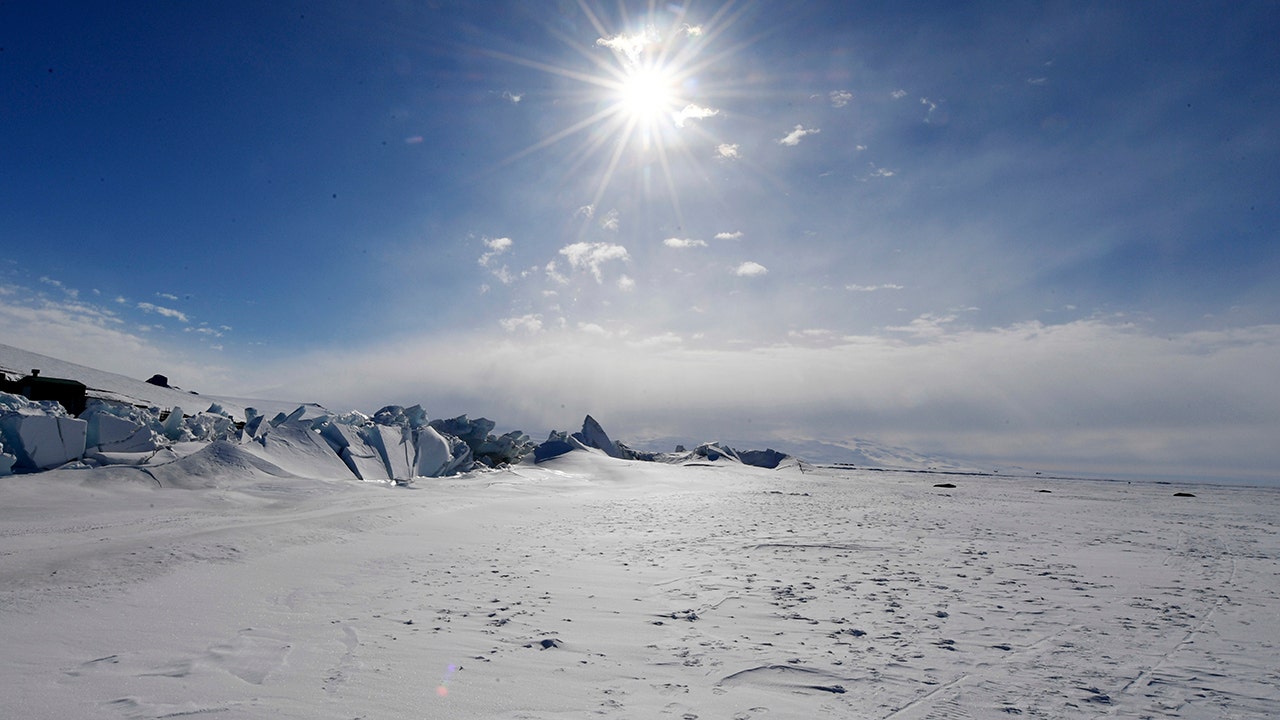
[0,0,1280,477]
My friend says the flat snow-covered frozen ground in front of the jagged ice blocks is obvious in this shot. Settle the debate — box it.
[0,452,1280,720]
